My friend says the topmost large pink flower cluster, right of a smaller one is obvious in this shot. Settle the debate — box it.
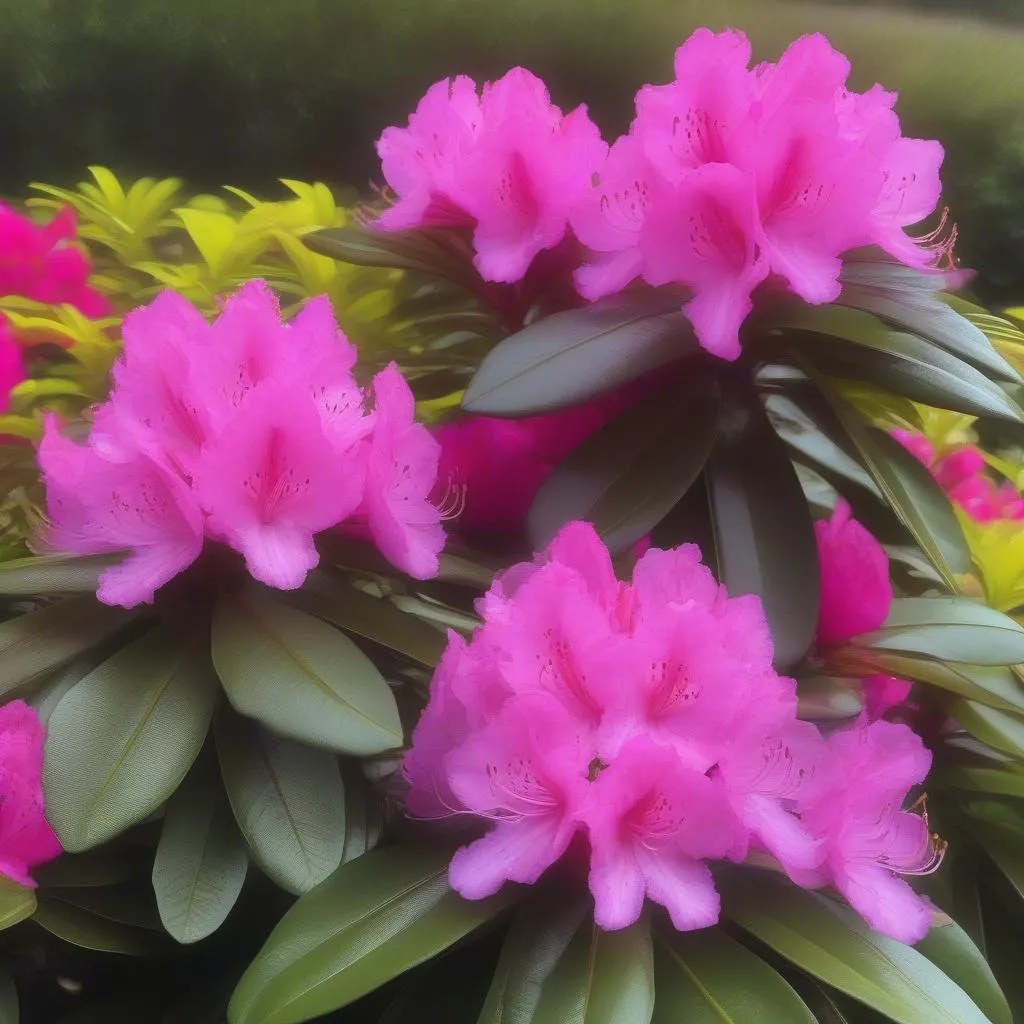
[571,29,951,359]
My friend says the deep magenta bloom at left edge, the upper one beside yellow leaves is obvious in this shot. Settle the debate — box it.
[0,203,110,316]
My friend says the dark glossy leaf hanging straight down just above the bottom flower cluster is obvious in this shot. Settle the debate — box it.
[706,376,820,671]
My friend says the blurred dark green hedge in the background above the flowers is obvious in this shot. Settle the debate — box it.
[6,0,1024,299]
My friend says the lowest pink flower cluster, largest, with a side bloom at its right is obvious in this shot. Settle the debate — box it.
[404,523,935,941]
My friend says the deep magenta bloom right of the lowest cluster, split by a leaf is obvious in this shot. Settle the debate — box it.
[814,499,910,721]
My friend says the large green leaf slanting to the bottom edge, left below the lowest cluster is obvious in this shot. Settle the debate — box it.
[227,846,518,1024]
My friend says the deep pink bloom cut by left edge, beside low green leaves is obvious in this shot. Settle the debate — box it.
[0,700,61,888]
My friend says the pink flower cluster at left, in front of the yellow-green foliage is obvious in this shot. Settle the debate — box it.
[39,281,444,606]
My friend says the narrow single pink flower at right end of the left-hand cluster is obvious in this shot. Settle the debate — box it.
[364,364,444,580]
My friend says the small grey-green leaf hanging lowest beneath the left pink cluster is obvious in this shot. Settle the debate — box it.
[153,757,249,942]
